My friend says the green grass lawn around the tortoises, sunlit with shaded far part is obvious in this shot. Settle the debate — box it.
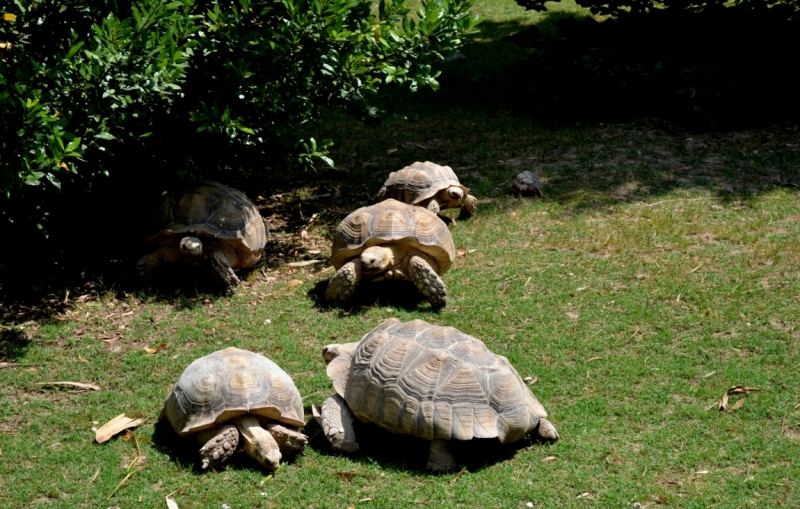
[0,0,800,509]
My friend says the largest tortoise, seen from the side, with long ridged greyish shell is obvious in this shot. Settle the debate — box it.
[312,318,558,472]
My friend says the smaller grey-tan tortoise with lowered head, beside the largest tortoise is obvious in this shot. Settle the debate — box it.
[158,347,308,470]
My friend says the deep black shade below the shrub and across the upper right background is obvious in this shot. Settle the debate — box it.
[0,0,800,304]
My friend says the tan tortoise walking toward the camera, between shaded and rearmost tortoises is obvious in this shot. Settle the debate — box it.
[325,199,456,308]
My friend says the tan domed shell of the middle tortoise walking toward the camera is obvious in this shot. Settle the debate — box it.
[332,199,456,274]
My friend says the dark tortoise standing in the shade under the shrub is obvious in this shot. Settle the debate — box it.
[137,182,269,295]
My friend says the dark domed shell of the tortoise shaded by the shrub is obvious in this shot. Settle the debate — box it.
[156,182,269,267]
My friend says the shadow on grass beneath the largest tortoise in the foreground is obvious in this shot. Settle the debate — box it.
[304,410,543,476]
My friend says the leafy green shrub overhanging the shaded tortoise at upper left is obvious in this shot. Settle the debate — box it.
[0,0,477,233]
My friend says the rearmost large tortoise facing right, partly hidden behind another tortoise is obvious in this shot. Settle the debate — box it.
[376,161,478,218]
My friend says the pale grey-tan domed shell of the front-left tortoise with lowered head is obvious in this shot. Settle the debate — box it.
[164,347,304,436]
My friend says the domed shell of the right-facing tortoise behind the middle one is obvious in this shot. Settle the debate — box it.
[377,161,469,205]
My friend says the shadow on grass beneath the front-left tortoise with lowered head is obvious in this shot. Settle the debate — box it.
[152,421,304,475]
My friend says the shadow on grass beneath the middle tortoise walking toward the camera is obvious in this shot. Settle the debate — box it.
[306,279,437,315]
